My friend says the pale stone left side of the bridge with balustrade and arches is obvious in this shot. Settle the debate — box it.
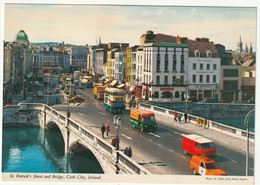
[7,103,151,175]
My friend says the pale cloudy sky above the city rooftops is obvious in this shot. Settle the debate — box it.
[4,3,256,51]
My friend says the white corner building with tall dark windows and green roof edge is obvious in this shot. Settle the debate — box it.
[142,42,189,101]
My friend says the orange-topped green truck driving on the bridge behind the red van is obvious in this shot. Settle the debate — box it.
[130,109,157,132]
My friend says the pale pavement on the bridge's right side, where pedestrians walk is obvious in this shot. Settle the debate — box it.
[151,110,255,157]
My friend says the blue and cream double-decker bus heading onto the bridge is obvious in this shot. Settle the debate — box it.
[104,88,125,114]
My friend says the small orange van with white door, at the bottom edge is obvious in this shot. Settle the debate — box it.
[190,155,227,175]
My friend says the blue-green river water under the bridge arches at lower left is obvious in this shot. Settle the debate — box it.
[2,127,103,174]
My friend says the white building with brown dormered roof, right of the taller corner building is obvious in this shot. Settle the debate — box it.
[186,38,221,100]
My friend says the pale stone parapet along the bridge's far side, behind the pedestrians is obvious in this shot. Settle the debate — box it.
[140,102,255,140]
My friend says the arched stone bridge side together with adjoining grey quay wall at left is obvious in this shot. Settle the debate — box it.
[3,103,150,174]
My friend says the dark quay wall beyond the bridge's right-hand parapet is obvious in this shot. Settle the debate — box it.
[145,102,255,119]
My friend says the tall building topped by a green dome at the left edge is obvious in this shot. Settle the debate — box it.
[4,30,33,103]
